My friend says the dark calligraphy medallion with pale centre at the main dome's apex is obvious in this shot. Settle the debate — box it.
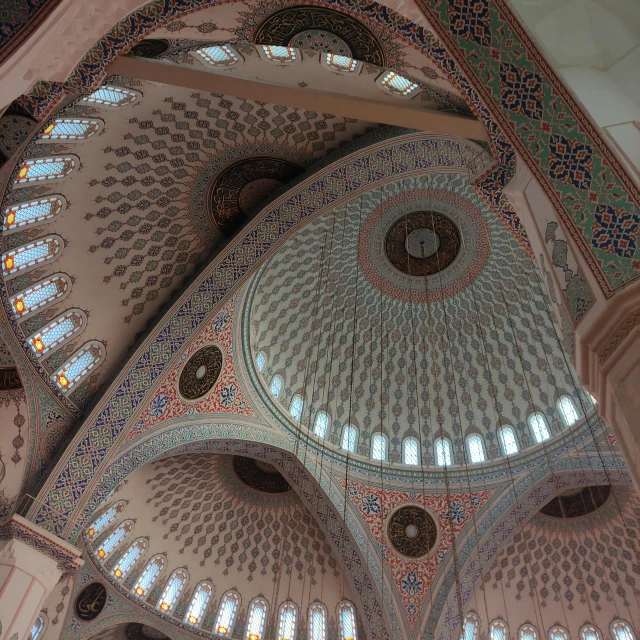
[384,211,461,276]
